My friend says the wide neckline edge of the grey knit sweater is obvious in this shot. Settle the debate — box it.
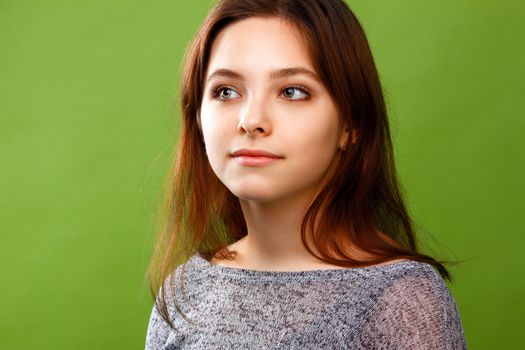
[190,253,418,278]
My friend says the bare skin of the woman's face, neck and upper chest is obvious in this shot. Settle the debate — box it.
[201,18,408,271]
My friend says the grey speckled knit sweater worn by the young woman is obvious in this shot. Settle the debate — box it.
[146,254,467,350]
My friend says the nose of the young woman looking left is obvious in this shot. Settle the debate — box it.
[237,96,272,136]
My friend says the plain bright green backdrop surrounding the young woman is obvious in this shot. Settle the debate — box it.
[0,0,525,349]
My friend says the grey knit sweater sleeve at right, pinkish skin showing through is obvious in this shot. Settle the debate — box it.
[361,270,467,350]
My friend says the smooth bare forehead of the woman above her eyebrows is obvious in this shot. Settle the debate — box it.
[208,17,313,76]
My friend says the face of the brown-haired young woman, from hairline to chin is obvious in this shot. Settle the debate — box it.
[200,17,347,202]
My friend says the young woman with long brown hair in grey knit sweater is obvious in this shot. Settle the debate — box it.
[146,0,467,349]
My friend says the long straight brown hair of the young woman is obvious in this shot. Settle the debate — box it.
[148,0,458,327]
